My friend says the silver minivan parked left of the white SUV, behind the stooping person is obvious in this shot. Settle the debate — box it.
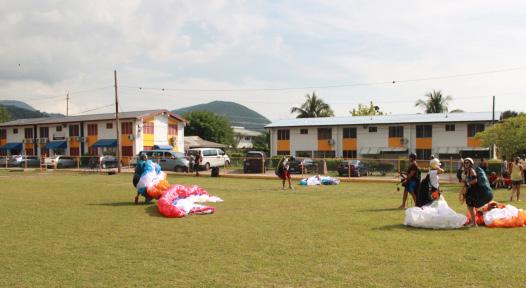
[130,150,190,172]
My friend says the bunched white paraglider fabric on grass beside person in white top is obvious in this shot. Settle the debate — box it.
[404,196,467,229]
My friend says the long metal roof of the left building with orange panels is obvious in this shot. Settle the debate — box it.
[0,109,186,127]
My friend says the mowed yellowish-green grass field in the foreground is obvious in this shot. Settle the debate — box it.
[0,173,526,287]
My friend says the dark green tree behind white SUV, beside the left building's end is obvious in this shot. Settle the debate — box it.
[183,111,235,146]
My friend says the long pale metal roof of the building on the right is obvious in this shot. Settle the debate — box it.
[265,112,501,128]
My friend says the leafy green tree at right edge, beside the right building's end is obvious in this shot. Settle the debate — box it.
[475,115,526,159]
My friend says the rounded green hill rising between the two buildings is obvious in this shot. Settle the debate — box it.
[172,101,270,131]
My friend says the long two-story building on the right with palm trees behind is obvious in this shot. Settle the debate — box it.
[265,112,500,159]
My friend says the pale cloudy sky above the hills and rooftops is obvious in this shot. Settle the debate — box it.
[0,0,526,121]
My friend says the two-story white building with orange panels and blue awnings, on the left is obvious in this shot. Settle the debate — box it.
[0,109,187,156]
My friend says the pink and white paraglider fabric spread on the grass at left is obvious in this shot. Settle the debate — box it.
[157,185,223,218]
